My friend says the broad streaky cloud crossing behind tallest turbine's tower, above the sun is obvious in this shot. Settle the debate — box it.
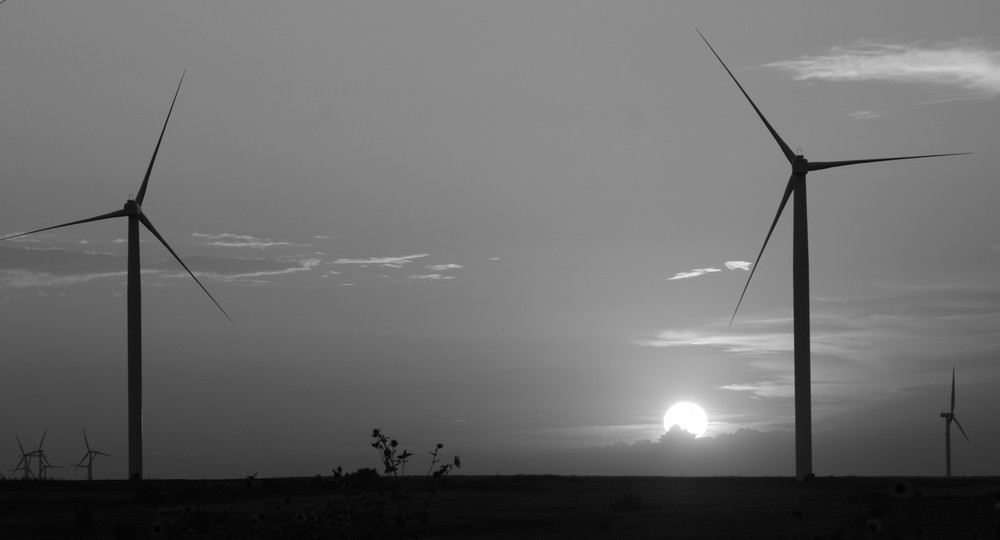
[632,285,1000,413]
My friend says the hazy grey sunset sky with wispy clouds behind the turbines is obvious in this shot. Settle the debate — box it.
[0,0,1000,478]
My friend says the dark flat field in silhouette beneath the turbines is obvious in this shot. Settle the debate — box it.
[0,476,1000,539]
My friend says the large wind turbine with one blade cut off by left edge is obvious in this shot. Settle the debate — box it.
[0,74,233,480]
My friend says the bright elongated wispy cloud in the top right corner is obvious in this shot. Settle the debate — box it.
[764,40,1000,97]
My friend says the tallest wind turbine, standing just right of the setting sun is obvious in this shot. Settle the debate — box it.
[698,30,968,481]
